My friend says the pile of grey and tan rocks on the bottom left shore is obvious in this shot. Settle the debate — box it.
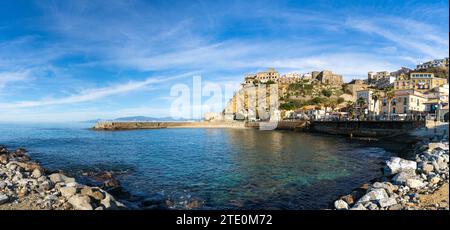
[0,146,126,210]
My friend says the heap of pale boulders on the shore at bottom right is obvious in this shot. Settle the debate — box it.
[334,137,449,210]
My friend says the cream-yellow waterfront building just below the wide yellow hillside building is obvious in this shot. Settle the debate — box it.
[381,90,428,115]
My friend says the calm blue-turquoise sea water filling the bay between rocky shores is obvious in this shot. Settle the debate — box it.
[0,123,392,209]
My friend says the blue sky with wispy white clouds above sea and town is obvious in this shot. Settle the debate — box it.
[0,0,449,122]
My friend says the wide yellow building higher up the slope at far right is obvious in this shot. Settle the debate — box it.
[394,73,447,91]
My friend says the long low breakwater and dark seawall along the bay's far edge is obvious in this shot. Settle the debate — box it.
[94,121,425,137]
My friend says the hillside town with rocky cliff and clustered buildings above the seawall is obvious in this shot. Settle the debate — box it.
[209,57,449,121]
